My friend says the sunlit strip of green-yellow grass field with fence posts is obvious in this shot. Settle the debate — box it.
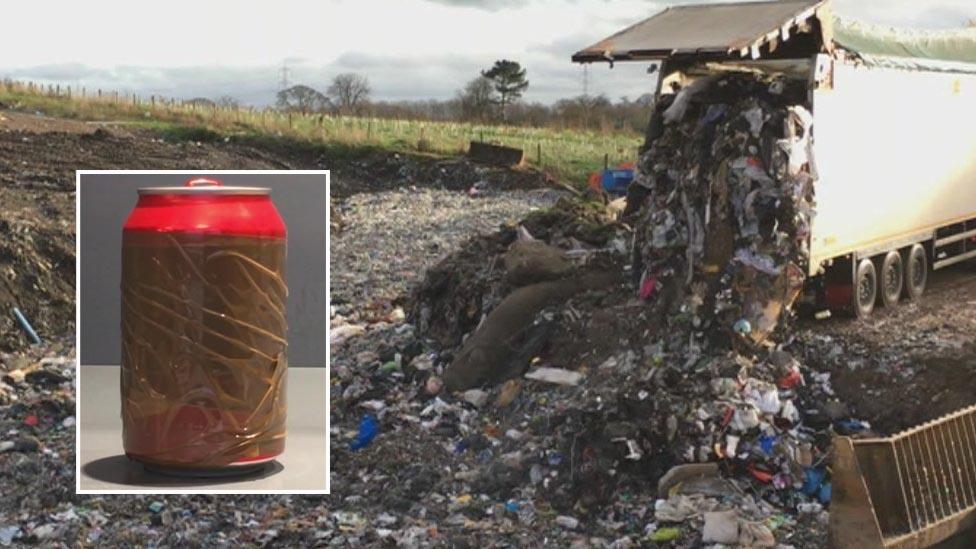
[0,81,641,185]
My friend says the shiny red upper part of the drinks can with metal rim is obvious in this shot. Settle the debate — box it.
[124,178,286,238]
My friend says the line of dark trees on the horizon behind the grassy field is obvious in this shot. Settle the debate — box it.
[266,59,653,132]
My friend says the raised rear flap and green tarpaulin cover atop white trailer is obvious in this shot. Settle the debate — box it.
[573,0,976,72]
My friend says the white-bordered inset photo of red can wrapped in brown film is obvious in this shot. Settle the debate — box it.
[76,171,329,494]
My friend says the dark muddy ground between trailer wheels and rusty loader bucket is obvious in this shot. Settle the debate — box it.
[797,263,976,434]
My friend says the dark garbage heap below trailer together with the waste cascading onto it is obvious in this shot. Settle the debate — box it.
[380,70,840,546]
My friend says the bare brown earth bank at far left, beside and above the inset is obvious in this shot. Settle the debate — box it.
[0,111,308,350]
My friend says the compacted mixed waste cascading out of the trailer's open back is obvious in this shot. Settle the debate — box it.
[635,74,816,343]
